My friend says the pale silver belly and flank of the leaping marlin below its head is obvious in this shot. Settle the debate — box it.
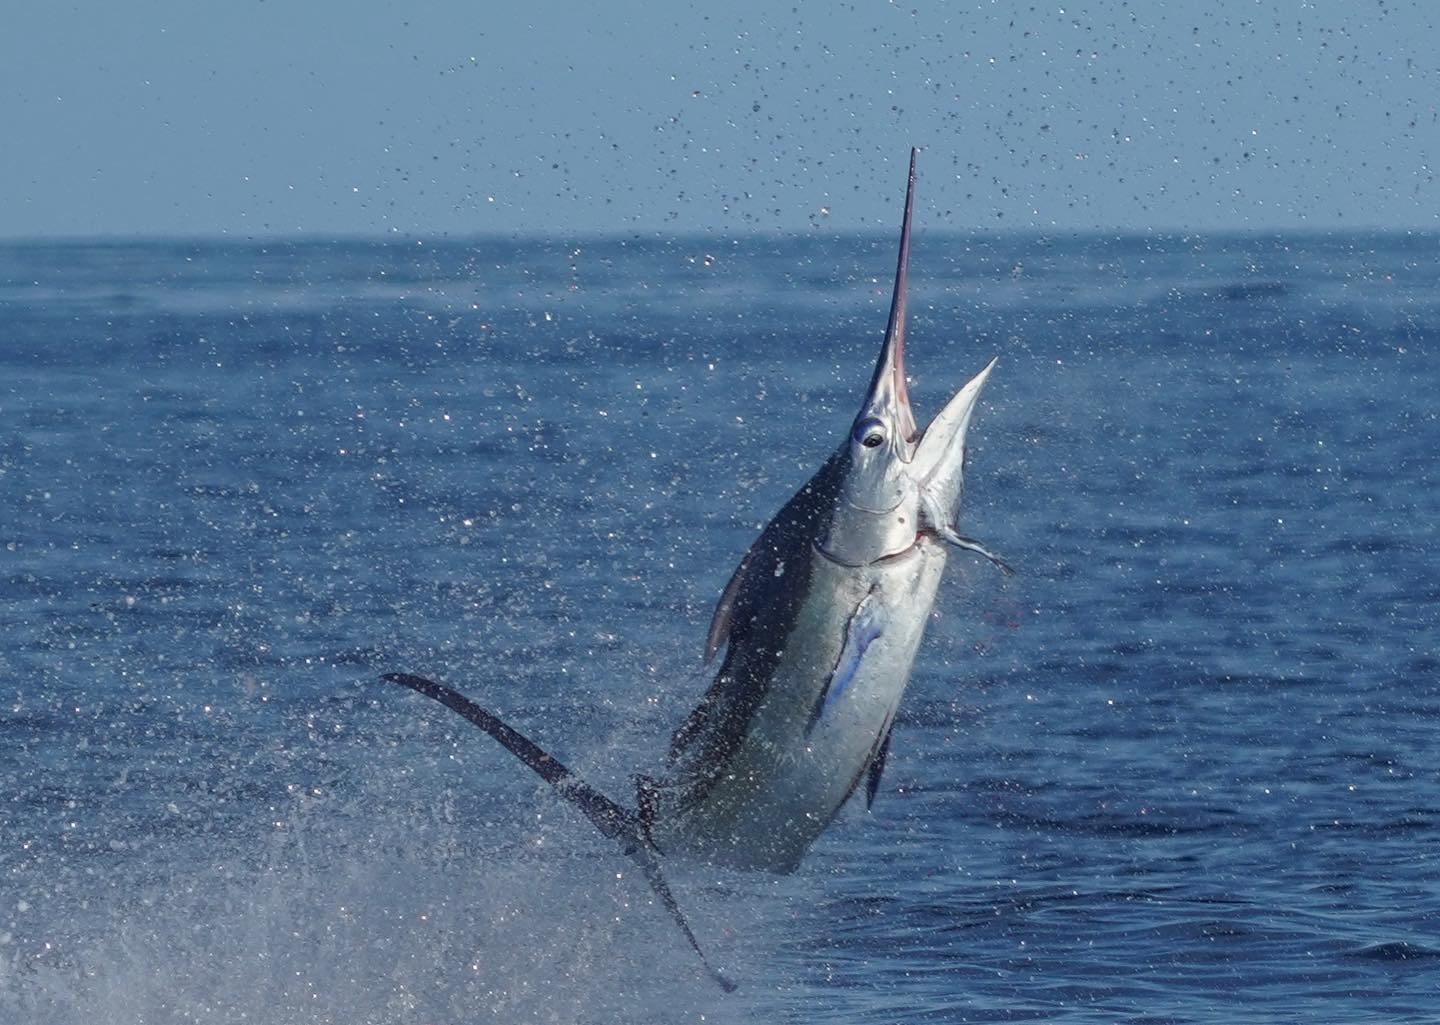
[645,537,946,872]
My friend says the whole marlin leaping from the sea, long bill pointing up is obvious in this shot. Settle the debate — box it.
[384,150,1011,990]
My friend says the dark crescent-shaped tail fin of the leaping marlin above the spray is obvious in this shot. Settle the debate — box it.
[380,672,736,993]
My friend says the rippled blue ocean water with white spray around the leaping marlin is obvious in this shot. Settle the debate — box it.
[0,229,1440,1025]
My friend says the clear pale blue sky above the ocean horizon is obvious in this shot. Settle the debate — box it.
[0,0,1440,238]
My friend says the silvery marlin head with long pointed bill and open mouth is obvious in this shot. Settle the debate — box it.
[819,150,1008,569]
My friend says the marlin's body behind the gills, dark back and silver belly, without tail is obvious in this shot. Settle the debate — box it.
[638,459,946,872]
